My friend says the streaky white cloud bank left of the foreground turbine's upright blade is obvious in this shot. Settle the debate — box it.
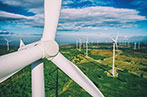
[0,11,44,27]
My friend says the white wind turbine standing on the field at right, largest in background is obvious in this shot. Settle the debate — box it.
[112,33,118,77]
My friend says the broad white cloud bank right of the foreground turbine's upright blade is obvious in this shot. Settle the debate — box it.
[60,6,146,29]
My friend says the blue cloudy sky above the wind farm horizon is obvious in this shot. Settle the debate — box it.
[0,0,147,44]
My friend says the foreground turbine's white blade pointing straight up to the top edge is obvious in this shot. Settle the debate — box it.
[41,0,62,41]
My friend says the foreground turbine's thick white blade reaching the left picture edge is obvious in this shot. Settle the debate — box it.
[0,46,43,83]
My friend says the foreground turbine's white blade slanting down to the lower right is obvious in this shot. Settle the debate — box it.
[51,53,104,97]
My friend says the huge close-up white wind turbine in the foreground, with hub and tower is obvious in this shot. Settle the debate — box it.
[0,0,104,97]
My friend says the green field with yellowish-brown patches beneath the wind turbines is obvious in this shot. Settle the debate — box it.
[0,44,147,97]
